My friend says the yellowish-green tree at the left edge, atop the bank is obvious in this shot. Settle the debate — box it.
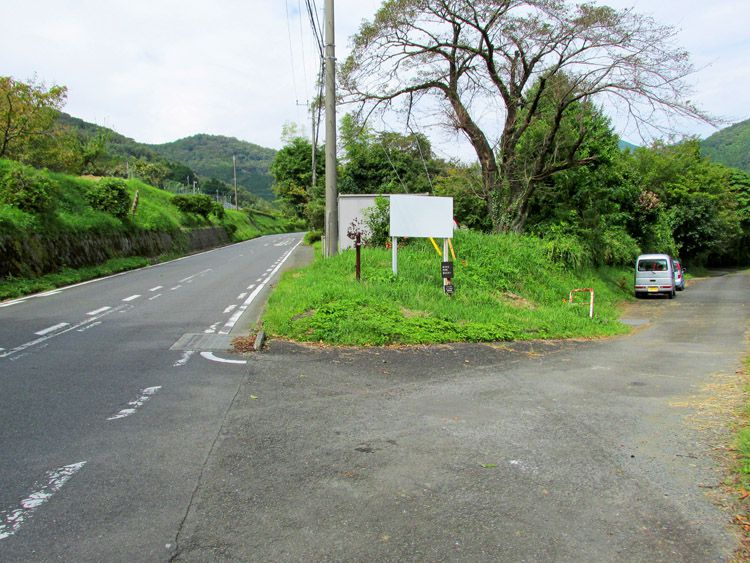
[0,76,67,160]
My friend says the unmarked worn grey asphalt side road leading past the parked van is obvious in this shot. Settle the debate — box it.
[173,274,750,562]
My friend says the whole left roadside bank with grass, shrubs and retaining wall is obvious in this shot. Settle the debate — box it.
[0,160,295,299]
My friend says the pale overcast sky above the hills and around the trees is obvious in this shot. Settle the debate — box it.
[0,0,750,157]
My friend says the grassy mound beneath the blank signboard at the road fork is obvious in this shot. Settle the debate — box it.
[264,231,632,345]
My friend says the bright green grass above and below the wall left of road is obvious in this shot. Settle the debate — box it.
[0,160,290,299]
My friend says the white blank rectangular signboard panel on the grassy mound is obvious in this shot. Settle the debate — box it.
[390,194,453,238]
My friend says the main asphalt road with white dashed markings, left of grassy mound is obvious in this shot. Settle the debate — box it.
[0,234,301,561]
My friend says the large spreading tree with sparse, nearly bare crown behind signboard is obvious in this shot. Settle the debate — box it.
[341,0,707,231]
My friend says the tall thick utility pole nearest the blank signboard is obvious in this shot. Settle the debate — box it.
[325,0,339,257]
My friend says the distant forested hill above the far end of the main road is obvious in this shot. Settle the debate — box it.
[144,134,276,199]
